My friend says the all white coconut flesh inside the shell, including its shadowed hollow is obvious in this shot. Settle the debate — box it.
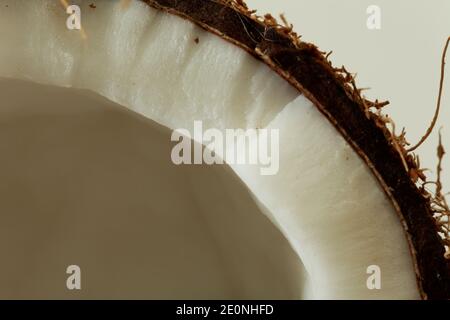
[0,0,419,299]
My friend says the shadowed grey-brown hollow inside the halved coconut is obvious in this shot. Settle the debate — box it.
[0,79,306,299]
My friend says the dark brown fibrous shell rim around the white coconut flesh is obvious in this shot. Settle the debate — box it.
[141,0,450,299]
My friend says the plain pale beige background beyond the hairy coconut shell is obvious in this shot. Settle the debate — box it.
[247,0,450,191]
